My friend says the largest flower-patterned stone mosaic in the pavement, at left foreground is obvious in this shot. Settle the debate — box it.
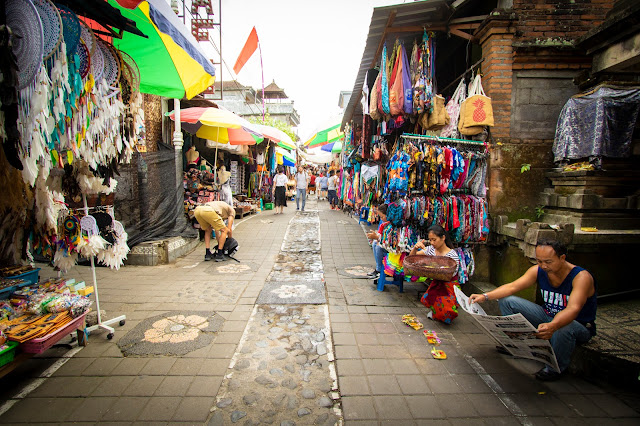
[118,311,224,356]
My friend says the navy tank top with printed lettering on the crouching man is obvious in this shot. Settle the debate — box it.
[538,266,596,324]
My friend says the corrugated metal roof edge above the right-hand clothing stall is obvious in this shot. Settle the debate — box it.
[342,0,452,128]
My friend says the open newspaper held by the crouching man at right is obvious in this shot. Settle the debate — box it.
[455,287,560,372]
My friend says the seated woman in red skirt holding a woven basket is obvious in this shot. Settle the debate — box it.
[409,225,460,324]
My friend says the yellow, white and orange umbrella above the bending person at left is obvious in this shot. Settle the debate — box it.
[168,107,264,145]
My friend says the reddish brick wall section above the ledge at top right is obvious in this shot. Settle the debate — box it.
[513,0,614,41]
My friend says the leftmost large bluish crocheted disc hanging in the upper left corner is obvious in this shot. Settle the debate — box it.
[5,0,44,89]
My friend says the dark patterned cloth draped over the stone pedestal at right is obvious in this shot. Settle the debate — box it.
[553,87,640,162]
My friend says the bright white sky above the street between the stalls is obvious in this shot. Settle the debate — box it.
[216,0,403,141]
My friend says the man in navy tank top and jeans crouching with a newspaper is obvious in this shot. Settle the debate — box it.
[469,241,596,381]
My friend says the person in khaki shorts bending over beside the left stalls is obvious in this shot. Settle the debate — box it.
[194,201,236,262]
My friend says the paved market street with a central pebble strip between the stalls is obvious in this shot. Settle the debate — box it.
[0,196,640,425]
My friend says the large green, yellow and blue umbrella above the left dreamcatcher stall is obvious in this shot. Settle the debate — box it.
[108,0,215,99]
